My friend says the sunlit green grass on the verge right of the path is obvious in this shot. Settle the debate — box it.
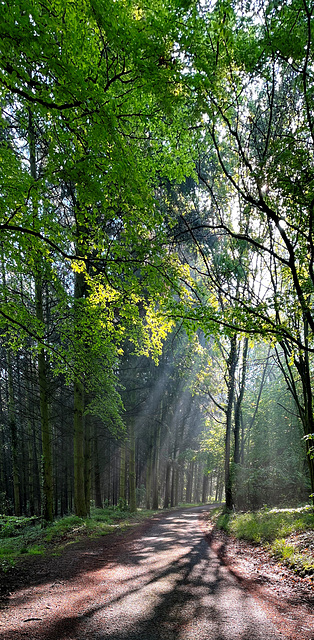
[213,505,314,575]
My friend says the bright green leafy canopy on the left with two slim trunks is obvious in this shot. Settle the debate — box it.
[0,0,196,519]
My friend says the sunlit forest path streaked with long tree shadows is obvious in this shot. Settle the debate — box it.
[0,507,285,640]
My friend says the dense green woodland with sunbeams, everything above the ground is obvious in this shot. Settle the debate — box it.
[0,0,314,521]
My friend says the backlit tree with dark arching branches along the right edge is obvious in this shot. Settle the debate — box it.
[175,0,314,500]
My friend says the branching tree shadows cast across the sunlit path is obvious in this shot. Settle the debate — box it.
[0,514,278,640]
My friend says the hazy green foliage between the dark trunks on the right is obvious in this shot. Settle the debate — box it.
[235,345,310,510]
